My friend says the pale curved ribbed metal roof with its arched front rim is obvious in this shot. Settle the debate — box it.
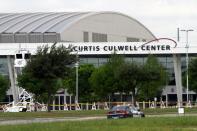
[0,12,155,37]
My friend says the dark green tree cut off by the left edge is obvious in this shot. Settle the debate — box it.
[0,74,9,101]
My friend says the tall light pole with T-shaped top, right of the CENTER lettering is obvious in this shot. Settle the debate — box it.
[181,29,194,103]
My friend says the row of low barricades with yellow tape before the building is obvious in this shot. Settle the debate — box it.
[0,101,197,111]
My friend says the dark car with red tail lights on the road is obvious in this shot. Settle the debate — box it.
[107,105,145,119]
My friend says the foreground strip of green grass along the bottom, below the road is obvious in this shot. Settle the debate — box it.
[0,116,197,131]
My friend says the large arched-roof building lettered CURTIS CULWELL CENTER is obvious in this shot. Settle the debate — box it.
[0,12,197,109]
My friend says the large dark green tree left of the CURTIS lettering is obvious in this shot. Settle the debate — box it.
[18,44,76,112]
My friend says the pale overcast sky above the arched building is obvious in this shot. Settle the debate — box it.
[0,0,197,45]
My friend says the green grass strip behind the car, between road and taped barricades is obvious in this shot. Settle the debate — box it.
[0,108,197,121]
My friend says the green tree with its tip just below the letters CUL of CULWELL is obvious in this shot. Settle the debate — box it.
[89,54,124,101]
